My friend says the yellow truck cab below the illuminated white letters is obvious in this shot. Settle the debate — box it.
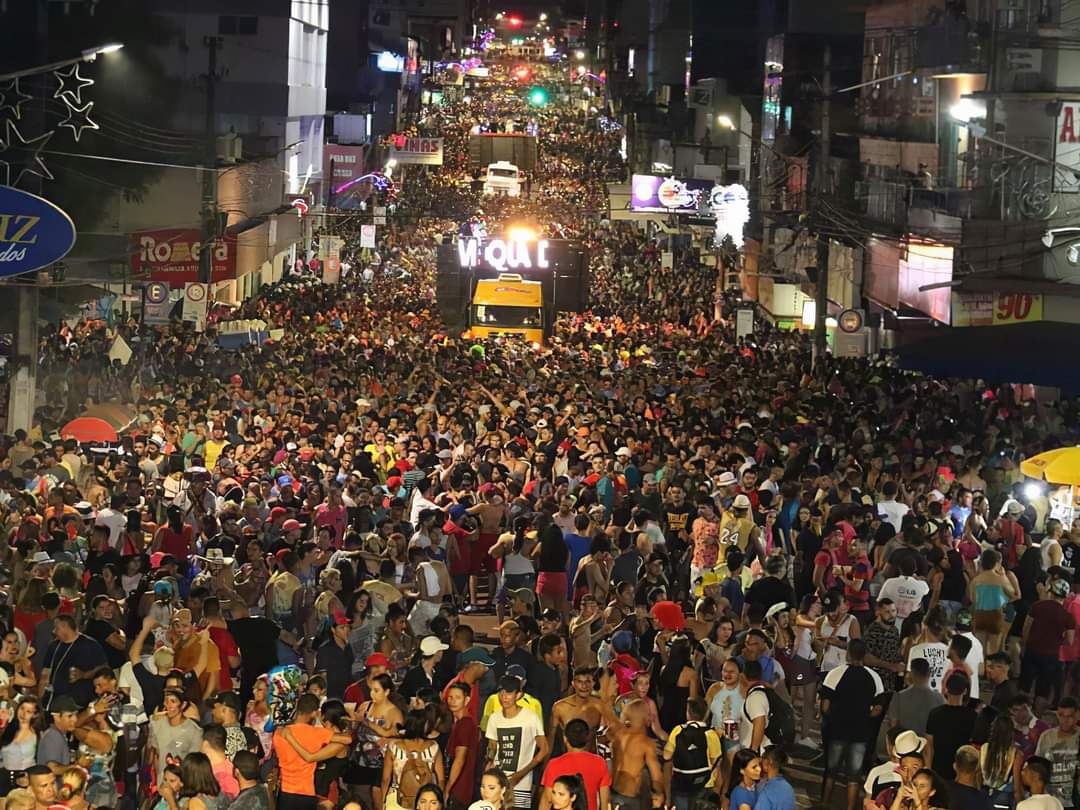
[469,273,545,343]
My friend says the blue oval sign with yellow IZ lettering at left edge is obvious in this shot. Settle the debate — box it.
[0,186,75,276]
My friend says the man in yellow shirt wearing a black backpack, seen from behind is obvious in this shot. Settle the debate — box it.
[664,698,723,810]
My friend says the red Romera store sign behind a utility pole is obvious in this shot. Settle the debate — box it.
[132,228,237,287]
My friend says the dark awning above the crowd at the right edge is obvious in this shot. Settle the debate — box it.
[895,323,1080,392]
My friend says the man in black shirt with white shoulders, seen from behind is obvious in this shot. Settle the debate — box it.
[821,638,885,810]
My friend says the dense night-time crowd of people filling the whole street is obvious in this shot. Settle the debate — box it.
[0,47,1080,810]
